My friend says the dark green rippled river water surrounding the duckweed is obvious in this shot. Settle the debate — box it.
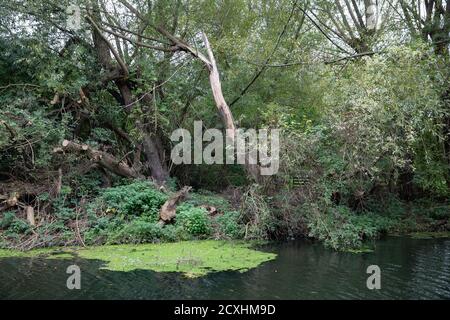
[0,237,450,299]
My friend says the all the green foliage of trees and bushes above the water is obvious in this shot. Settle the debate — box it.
[0,0,450,249]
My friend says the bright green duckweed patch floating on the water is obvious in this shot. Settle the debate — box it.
[0,240,276,277]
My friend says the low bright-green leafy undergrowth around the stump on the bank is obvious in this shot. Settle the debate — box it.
[81,182,244,244]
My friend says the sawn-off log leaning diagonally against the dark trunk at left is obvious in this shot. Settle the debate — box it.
[54,140,143,178]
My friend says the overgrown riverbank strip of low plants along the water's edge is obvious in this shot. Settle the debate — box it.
[0,181,450,252]
